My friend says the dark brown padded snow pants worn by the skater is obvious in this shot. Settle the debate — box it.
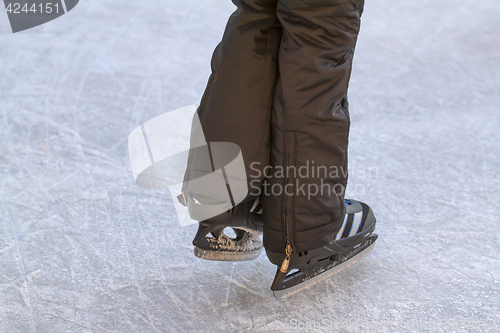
[191,0,364,253]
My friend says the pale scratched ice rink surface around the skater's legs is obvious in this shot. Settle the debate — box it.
[0,0,500,333]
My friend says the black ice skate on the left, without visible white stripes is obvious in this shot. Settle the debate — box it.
[188,193,263,261]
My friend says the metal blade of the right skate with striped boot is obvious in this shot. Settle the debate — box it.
[273,242,376,300]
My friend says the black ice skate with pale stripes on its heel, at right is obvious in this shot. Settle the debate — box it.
[266,200,378,298]
